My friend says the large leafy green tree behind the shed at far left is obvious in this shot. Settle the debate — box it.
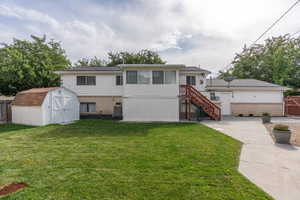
[0,35,71,95]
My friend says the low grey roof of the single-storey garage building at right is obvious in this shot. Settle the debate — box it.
[206,79,288,90]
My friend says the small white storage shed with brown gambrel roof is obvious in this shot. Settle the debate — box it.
[12,87,79,126]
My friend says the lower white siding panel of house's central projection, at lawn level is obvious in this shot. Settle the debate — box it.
[123,98,179,121]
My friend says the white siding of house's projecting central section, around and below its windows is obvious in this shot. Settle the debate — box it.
[123,70,179,121]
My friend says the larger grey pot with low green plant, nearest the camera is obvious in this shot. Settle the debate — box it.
[273,124,291,144]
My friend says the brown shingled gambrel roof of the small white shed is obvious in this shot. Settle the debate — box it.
[12,87,59,106]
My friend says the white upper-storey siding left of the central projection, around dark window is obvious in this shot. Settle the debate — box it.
[61,74,123,96]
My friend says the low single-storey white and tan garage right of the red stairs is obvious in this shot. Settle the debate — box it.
[207,79,289,116]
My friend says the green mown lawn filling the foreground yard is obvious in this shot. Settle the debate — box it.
[0,120,271,200]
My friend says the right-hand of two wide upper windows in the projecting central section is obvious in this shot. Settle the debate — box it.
[152,71,176,84]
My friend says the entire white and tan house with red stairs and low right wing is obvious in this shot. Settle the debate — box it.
[57,64,285,121]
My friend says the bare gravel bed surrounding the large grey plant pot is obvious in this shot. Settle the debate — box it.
[264,122,300,146]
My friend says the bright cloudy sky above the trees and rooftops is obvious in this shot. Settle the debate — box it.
[0,0,300,72]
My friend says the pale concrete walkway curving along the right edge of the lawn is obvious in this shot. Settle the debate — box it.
[202,117,300,200]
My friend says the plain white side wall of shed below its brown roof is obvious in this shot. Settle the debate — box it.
[12,106,45,126]
